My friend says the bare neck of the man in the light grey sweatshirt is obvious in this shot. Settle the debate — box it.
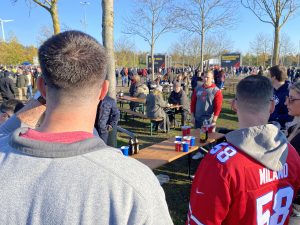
[37,104,97,133]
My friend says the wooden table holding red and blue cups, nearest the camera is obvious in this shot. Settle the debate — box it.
[132,129,224,170]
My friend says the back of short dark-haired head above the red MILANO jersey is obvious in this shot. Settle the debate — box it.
[236,76,273,116]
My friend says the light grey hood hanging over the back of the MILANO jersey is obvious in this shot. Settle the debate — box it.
[225,124,288,171]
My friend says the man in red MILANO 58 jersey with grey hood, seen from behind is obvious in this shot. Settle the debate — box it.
[186,76,300,225]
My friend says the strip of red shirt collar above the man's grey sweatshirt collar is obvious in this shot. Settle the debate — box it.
[21,129,93,144]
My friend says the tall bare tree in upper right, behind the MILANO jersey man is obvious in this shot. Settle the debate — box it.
[241,0,299,64]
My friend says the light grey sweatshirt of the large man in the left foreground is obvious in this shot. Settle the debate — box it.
[0,125,173,225]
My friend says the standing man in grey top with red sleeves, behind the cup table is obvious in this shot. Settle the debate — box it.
[191,71,223,159]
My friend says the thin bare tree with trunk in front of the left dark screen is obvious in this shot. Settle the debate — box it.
[123,0,177,79]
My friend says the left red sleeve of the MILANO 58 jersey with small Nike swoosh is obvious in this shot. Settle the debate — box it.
[186,155,231,225]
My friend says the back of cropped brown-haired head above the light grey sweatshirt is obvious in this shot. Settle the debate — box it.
[38,31,106,100]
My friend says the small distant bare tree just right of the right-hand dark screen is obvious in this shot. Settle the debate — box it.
[250,33,271,66]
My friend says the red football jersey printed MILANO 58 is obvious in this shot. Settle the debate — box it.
[186,143,300,225]
